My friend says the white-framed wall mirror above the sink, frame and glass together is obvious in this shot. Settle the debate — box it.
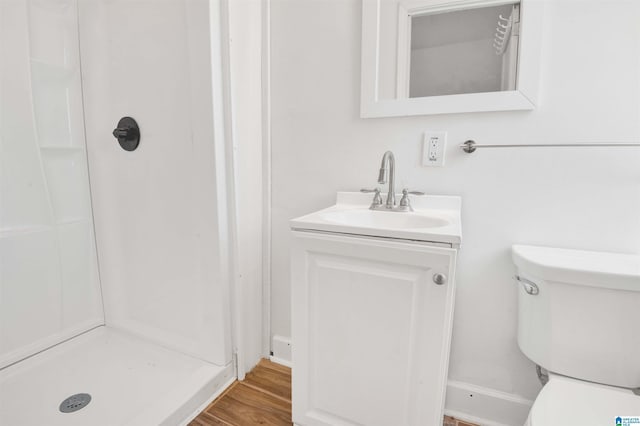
[361,0,542,117]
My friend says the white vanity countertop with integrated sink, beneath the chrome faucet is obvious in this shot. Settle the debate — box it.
[290,192,462,247]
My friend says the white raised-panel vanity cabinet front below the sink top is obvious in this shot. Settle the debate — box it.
[291,232,456,426]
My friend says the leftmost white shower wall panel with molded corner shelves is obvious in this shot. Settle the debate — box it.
[0,0,104,368]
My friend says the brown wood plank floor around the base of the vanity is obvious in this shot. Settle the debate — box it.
[189,359,477,426]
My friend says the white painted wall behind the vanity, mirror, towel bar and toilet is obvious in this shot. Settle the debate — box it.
[271,0,640,420]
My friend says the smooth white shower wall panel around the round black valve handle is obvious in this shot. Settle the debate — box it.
[80,0,232,365]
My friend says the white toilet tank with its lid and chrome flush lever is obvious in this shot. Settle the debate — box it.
[512,245,640,388]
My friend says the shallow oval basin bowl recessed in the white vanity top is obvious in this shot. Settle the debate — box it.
[321,209,450,229]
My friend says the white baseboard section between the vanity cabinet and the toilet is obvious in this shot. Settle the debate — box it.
[444,380,533,426]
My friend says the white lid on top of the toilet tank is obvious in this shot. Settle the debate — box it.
[512,245,640,291]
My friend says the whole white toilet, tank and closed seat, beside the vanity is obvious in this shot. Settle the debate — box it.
[513,245,640,426]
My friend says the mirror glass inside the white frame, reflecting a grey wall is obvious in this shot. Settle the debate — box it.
[379,1,520,99]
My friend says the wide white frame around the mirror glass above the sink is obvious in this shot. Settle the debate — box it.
[360,0,543,118]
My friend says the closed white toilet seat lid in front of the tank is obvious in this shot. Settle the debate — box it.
[527,374,640,426]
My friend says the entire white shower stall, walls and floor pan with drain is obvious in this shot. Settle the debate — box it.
[0,0,236,426]
